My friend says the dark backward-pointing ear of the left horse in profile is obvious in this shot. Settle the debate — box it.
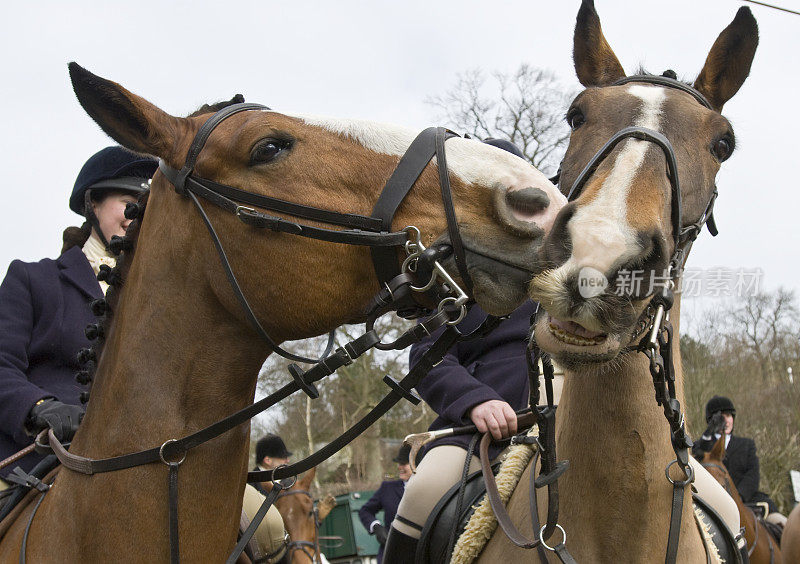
[69,62,186,159]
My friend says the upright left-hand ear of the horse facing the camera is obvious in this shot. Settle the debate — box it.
[572,0,625,88]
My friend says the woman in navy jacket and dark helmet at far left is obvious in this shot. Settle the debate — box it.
[0,146,158,482]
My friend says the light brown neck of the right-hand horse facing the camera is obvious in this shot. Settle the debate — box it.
[556,301,694,561]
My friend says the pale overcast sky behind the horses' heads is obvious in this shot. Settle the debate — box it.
[0,0,800,312]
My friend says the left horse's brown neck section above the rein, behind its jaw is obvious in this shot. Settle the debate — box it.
[75,203,269,456]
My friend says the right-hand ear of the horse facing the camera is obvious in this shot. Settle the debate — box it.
[694,7,758,111]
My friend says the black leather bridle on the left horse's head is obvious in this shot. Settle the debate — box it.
[159,103,472,364]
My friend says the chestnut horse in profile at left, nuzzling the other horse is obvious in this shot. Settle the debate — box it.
[0,63,565,562]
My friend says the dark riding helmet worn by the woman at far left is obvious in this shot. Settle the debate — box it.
[69,145,158,247]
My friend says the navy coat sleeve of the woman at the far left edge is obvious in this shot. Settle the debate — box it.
[0,260,53,443]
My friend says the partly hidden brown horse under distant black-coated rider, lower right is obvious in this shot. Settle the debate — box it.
[700,436,783,564]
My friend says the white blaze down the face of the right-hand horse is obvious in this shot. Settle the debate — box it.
[558,84,666,274]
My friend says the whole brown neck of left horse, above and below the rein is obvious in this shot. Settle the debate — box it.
[41,188,269,561]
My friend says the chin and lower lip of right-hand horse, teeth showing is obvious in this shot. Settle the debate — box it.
[534,314,631,374]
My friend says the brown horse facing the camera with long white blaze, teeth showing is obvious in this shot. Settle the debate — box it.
[480,0,758,562]
